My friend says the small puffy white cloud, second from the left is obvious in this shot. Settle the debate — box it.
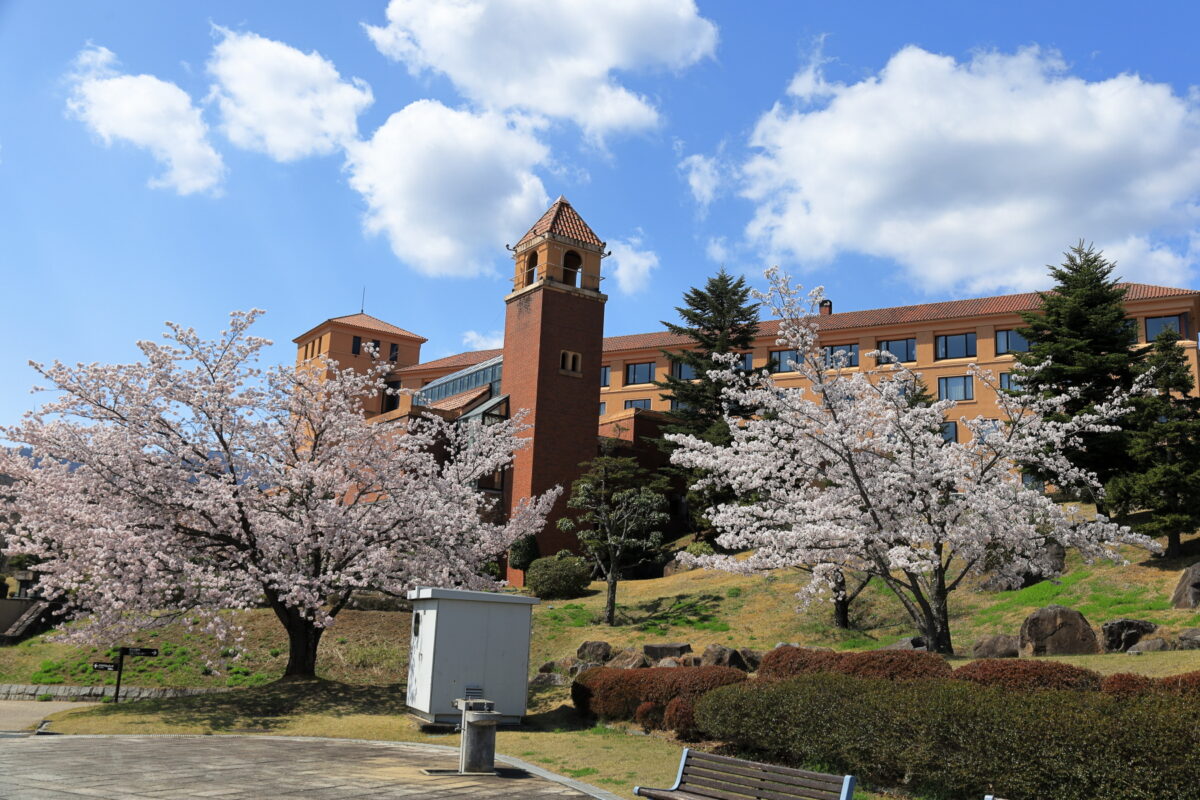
[208,28,373,161]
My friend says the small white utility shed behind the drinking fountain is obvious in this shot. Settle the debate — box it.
[407,587,539,724]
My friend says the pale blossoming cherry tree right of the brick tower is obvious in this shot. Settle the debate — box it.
[672,269,1157,654]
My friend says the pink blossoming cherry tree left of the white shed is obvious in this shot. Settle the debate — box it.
[0,311,557,678]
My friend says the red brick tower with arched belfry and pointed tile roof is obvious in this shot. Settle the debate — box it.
[502,197,608,585]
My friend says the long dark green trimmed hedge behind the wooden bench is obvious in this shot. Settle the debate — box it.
[695,674,1200,800]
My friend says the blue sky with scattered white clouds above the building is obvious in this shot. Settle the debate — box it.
[0,0,1200,423]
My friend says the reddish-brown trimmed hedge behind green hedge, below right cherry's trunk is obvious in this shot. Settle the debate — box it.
[758,644,953,680]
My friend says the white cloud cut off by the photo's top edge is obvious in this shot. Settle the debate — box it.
[366,0,716,139]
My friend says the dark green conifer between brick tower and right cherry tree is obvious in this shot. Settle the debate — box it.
[655,267,758,444]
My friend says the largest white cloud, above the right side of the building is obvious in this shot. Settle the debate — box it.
[743,47,1200,291]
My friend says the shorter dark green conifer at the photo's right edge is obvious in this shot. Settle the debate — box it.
[1105,330,1200,558]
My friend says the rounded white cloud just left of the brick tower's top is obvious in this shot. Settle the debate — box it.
[347,100,550,276]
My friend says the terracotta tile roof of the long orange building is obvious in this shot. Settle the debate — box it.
[388,283,1200,373]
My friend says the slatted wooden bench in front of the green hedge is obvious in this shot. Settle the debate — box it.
[634,747,854,800]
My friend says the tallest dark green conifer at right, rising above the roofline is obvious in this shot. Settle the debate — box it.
[1018,241,1145,494]
